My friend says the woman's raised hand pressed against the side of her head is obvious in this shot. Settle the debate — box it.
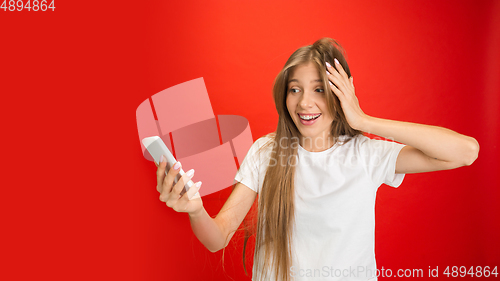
[326,59,368,130]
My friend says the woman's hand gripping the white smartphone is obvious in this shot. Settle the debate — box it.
[156,156,203,215]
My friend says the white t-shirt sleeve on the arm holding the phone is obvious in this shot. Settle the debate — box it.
[234,137,271,193]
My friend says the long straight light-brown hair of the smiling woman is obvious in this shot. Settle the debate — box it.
[243,38,361,281]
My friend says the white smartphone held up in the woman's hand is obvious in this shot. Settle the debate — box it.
[142,136,196,195]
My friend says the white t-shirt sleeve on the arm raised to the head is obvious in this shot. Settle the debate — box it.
[358,136,405,187]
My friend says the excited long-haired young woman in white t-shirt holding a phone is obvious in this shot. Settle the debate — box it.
[157,38,479,280]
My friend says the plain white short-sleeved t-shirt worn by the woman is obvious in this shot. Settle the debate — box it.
[235,135,404,280]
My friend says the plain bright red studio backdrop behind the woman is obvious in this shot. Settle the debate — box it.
[0,0,500,280]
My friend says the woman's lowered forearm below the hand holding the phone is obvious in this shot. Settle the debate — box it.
[189,208,226,252]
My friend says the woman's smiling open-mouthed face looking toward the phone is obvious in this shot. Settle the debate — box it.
[286,63,333,149]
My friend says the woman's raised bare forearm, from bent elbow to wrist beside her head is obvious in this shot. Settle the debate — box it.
[360,116,479,165]
